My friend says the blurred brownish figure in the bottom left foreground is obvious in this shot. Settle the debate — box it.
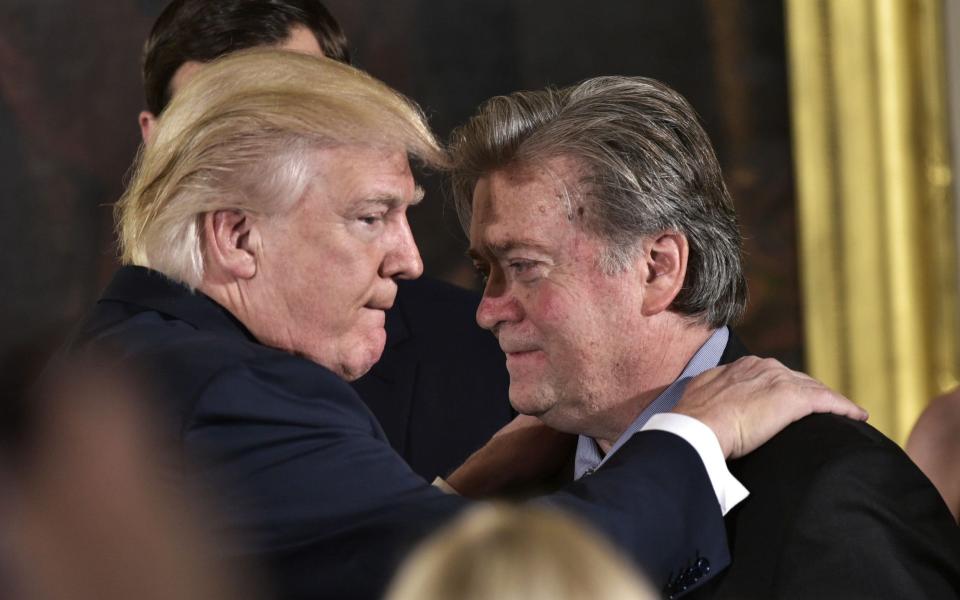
[0,363,260,600]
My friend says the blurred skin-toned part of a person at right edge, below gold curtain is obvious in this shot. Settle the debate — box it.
[907,388,960,519]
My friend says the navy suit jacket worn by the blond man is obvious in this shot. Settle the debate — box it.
[72,267,729,599]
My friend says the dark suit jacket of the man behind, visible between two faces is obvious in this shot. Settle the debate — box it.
[353,278,514,481]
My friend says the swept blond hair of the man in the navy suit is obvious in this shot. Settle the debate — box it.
[114,49,447,288]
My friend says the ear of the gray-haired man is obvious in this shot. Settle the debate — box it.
[641,231,690,316]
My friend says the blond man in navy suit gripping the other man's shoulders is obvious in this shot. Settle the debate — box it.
[69,50,865,598]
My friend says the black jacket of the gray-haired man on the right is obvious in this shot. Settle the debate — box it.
[689,335,960,600]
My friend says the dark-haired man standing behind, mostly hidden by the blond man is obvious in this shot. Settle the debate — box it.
[139,0,516,480]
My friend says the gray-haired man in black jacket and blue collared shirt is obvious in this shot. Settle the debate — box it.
[452,77,960,598]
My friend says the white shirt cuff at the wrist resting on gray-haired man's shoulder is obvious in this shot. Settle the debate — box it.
[640,413,750,515]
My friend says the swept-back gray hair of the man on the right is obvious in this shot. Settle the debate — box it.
[450,76,747,327]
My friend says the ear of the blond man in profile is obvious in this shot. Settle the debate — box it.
[203,210,260,283]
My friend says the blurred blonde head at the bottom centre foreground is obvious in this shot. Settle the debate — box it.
[387,505,657,600]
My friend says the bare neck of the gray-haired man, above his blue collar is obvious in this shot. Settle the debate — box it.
[593,322,714,453]
